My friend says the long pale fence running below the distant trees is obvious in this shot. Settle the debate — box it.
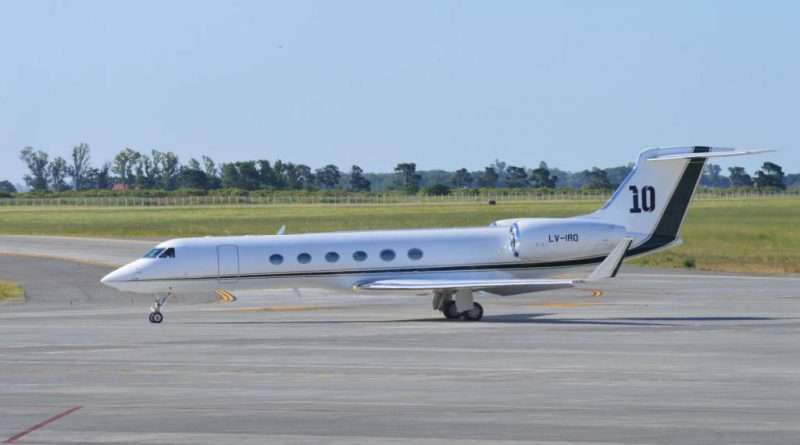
[0,189,800,207]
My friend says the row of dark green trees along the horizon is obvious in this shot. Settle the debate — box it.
[0,143,800,194]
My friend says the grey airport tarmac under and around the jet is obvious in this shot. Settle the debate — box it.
[0,236,800,444]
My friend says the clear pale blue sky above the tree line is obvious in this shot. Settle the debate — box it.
[0,0,800,182]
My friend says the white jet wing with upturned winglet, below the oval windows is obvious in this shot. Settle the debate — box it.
[354,238,633,295]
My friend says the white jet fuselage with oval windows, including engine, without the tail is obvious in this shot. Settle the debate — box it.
[103,217,626,294]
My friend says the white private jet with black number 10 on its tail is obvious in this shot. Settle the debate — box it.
[102,146,768,323]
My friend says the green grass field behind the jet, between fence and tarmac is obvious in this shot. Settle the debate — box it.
[0,198,800,273]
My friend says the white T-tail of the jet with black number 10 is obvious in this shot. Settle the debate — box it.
[589,146,771,256]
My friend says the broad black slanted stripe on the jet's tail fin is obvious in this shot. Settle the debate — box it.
[627,147,711,256]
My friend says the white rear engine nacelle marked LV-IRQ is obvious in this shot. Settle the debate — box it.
[498,218,626,261]
